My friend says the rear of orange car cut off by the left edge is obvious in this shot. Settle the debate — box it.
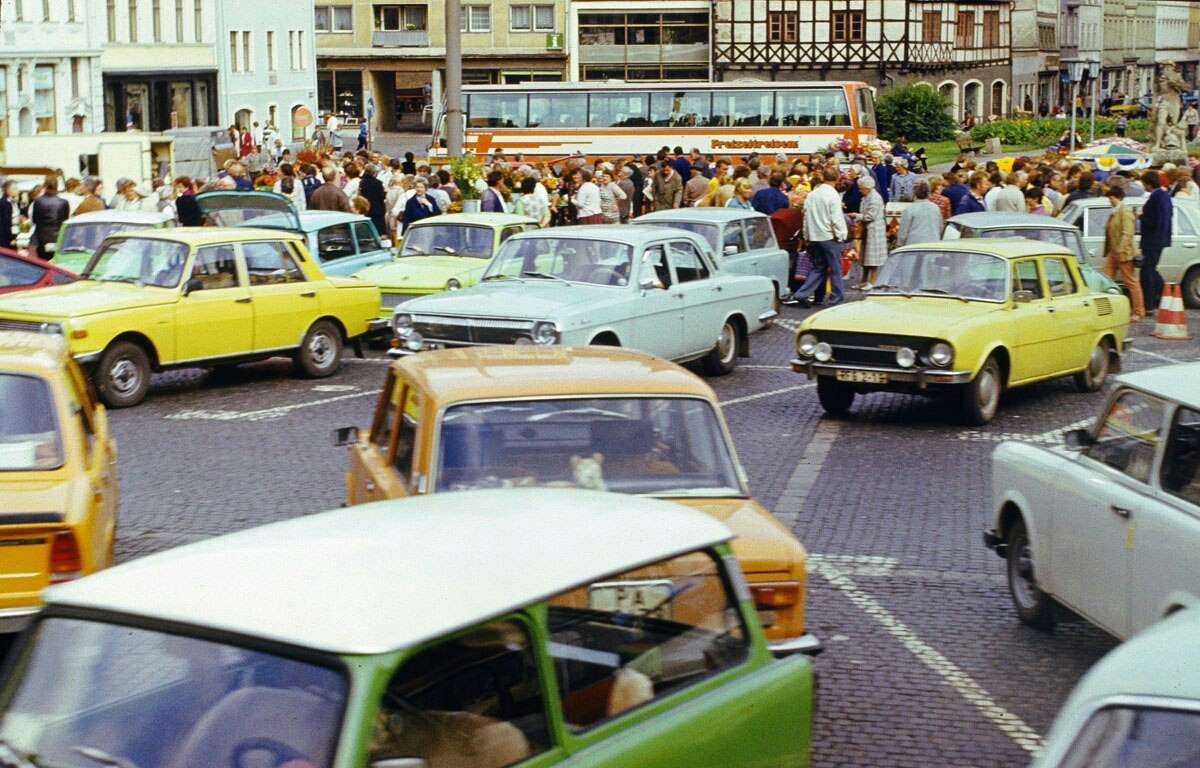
[0,331,116,635]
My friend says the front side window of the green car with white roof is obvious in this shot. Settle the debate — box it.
[370,619,550,766]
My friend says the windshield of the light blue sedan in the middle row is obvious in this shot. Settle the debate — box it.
[484,236,634,286]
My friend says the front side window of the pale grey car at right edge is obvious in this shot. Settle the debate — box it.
[1086,390,1164,482]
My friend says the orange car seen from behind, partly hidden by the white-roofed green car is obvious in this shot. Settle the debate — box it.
[335,347,821,655]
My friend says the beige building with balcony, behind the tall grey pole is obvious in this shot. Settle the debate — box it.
[314,0,566,131]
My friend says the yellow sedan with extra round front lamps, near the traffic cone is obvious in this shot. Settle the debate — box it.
[792,238,1129,425]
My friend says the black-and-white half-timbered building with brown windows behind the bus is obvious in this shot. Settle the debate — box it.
[713,0,1012,119]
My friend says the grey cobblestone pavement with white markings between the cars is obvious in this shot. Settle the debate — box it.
[18,302,1200,768]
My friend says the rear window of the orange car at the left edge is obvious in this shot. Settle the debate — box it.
[0,371,62,472]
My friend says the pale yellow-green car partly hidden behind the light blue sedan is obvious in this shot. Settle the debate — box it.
[354,214,538,319]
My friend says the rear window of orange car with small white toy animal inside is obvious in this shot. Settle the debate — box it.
[437,397,743,497]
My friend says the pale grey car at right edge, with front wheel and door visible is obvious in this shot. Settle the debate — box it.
[984,362,1200,640]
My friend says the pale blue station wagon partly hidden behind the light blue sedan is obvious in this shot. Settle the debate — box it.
[636,208,791,310]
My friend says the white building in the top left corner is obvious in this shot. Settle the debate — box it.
[0,0,103,149]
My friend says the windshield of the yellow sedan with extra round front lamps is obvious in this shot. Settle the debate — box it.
[871,251,1008,301]
